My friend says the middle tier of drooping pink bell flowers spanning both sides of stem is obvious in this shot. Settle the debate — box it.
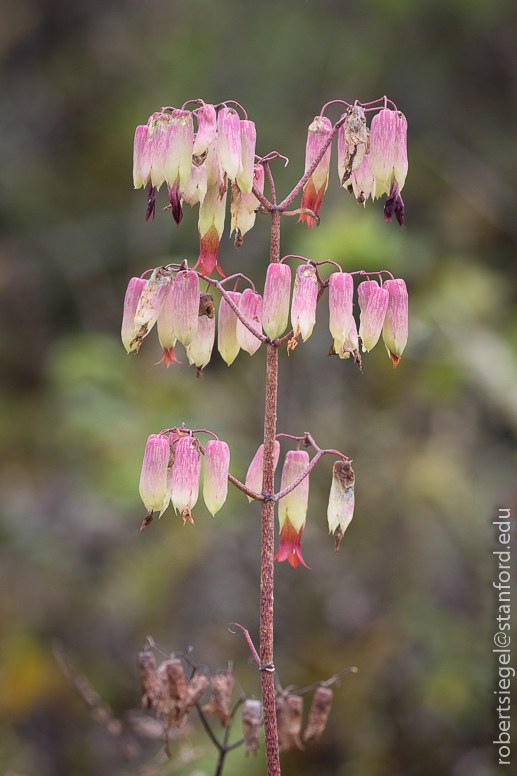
[122,260,408,375]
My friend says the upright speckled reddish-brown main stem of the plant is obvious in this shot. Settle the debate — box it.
[260,212,280,776]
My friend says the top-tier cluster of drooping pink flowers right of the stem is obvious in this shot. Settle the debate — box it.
[299,100,408,227]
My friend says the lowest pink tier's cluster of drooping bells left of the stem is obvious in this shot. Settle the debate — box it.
[140,427,230,528]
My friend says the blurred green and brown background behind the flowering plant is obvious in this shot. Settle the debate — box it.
[0,0,517,776]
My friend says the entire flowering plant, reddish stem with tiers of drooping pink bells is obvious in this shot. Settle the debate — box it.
[126,97,408,776]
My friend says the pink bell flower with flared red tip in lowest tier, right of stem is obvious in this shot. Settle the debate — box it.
[275,450,309,568]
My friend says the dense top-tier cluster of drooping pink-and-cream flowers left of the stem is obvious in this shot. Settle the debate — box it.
[133,100,264,275]
